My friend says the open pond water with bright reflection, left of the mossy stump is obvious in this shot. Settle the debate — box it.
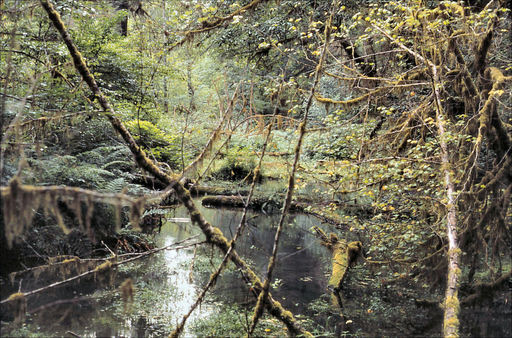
[10,201,330,337]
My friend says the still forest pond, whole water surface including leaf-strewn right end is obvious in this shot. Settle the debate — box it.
[2,201,512,337]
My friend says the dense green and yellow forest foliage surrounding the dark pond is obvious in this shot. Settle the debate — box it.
[0,0,512,335]
